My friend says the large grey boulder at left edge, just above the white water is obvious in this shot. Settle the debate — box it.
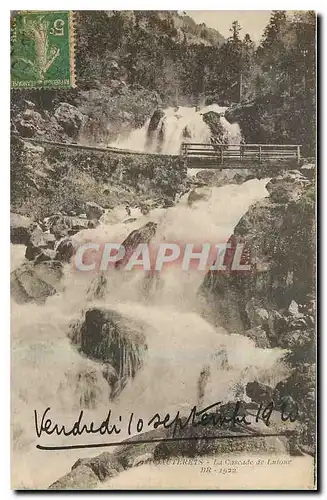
[10,261,62,304]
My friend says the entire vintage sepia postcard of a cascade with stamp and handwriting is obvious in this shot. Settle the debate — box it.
[10,10,317,491]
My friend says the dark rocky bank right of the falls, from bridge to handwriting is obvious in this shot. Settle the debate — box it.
[202,171,315,453]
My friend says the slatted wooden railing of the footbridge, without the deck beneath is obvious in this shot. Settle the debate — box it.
[181,142,301,164]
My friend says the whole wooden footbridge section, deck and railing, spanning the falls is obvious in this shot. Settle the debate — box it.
[181,142,301,169]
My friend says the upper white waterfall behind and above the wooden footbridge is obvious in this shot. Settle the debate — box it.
[110,104,241,154]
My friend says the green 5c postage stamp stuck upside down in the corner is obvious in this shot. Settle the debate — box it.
[11,11,75,89]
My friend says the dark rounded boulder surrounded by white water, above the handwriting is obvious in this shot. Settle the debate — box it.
[71,308,147,399]
